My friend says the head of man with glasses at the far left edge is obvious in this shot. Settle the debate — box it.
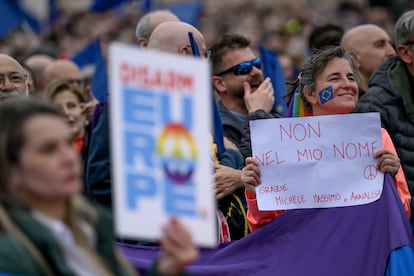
[0,54,30,101]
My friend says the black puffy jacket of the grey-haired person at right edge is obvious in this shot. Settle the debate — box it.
[355,56,414,196]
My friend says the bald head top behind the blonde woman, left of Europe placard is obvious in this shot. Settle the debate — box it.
[39,59,82,91]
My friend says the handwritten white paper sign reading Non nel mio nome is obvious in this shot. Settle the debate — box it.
[250,113,384,210]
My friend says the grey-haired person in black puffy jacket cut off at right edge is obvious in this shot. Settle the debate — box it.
[355,10,414,204]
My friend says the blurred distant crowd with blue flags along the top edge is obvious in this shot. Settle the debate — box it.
[0,0,414,75]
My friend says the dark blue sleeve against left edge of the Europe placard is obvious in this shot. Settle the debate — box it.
[85,108,112,207]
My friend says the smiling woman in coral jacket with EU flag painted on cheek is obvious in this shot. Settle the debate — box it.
[242,47,411,231]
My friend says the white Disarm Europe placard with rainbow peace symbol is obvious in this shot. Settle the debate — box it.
[109,44,218,246]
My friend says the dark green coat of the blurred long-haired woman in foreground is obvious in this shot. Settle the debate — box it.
[0,201,133,275]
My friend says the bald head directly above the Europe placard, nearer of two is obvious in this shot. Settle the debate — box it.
[147,21,207,57]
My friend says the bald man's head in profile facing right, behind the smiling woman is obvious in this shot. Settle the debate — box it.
[341,24,396,91]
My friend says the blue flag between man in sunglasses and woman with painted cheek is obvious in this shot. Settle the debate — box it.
[259,46,287,116]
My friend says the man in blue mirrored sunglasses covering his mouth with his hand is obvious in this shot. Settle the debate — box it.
[210,34,280,152]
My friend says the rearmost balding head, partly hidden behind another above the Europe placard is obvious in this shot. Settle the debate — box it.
[135,10,180,47]
